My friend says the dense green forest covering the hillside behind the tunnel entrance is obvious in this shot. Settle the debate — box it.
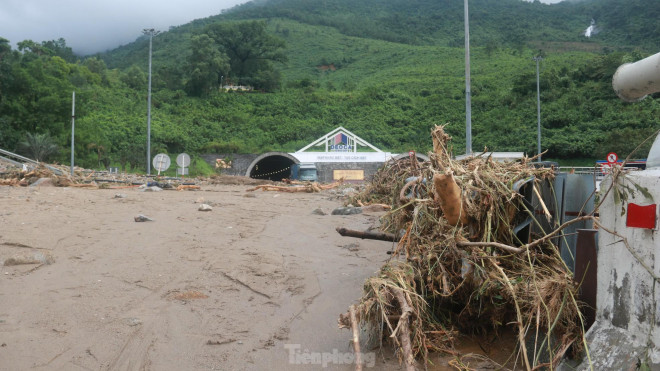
[0,0,660,171]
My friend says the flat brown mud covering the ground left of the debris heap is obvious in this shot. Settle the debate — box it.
[0,184,398,370]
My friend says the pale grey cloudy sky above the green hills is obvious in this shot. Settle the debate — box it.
[0,0,561,55]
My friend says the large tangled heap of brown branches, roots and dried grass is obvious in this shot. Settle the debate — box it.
[339,126,583,370]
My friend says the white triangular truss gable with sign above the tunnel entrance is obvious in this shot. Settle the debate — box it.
[291,126,392,162]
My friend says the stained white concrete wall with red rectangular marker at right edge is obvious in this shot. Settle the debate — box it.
[596,170,660,364]
